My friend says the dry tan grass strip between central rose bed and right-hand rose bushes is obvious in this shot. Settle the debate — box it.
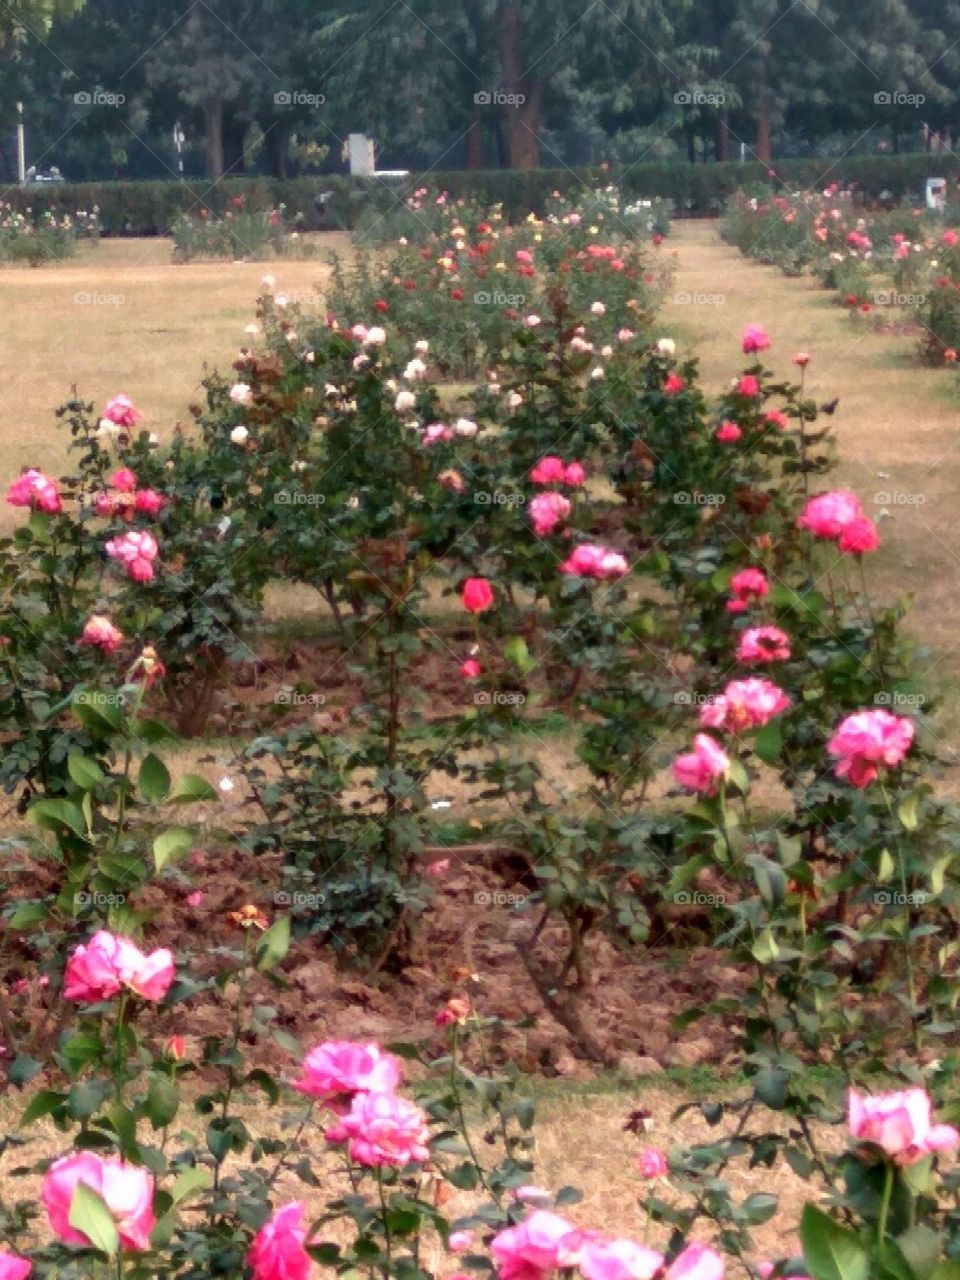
[663,221,960,745]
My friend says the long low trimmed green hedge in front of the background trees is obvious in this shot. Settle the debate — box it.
[9,155,954,236]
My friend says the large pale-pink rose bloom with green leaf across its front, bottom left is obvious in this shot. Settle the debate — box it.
[40,1151,156,1251]
